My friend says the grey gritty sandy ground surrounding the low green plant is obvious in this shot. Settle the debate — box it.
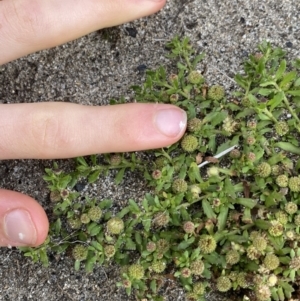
[0,0,300,301]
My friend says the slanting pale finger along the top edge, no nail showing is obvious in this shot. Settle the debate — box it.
[0,0,166,65]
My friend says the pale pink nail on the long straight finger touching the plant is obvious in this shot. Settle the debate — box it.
[155,108,187,138]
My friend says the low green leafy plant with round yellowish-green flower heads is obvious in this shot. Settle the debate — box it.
[22,37,300,301]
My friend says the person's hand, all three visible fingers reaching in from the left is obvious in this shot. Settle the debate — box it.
[0,0,186,246]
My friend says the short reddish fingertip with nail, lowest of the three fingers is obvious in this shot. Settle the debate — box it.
[0,189,49,247]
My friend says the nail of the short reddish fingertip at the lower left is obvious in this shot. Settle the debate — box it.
[4,209,36,245]
